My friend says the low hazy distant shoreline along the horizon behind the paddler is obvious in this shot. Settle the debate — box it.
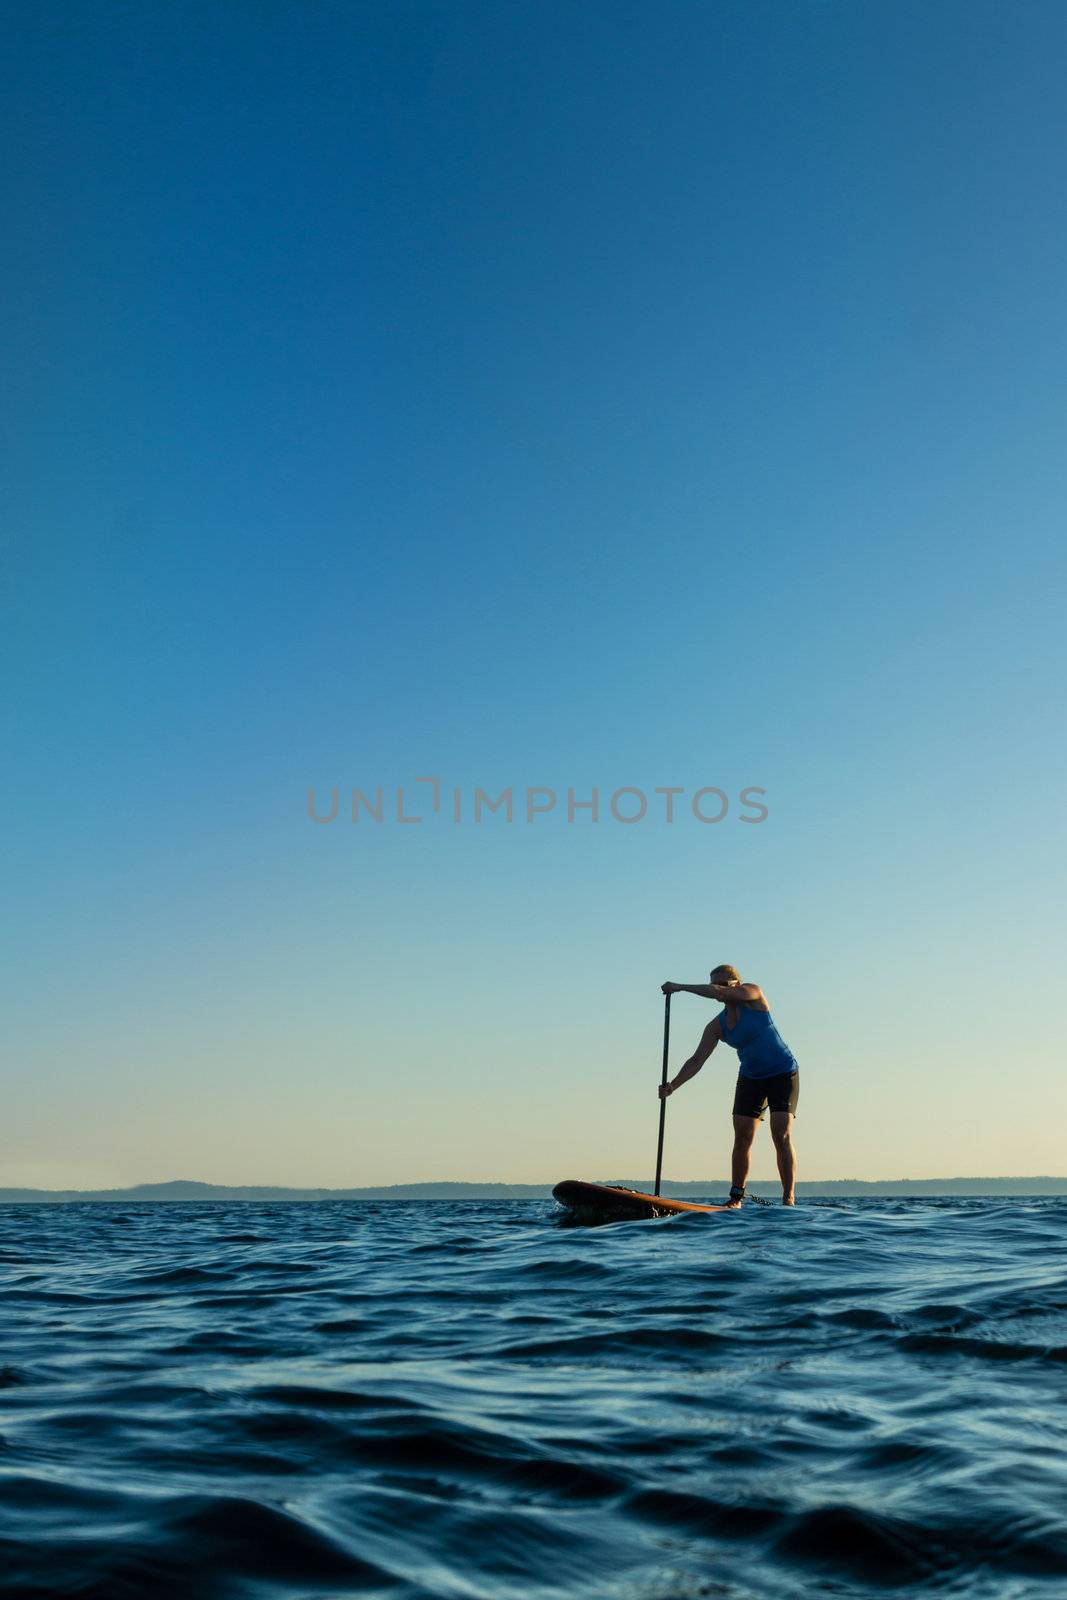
[0,1178,1067,1205]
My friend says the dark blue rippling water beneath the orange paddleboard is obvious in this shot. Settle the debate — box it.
[0,1198,1067,1600]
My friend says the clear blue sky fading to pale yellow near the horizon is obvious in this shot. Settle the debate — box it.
[0,0,1067,1186]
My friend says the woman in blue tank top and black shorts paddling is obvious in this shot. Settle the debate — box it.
[659,966,800,1206]
